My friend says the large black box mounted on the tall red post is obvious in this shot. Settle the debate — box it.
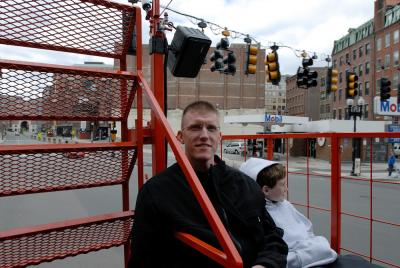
[168,26,211,78]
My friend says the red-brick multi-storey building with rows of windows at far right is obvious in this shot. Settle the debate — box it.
[332,0,400,120]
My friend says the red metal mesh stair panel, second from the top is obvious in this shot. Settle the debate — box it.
[0,61,136,121]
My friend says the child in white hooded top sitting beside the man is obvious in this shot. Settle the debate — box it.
[240,158,337,268]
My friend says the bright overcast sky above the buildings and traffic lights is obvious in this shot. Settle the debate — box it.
[0,0,374,74]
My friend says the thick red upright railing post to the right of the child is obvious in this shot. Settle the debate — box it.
[331,134,341,254]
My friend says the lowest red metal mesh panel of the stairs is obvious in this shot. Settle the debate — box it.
[0,216,133,268]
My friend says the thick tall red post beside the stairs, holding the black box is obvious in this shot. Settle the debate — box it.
[150,0,166,175]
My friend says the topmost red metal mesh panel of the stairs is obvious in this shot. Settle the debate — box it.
[0,0,135,58]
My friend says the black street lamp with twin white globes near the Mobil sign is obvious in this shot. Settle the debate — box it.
[346,97,365,176]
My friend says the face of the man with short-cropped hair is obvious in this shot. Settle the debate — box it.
[177,110,221,170]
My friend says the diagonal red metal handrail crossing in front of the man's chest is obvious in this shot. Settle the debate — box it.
[138,71,243,268]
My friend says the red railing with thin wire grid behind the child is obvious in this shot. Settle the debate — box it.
[221,132,400,268]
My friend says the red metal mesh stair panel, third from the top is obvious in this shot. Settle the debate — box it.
[0,149,136,197]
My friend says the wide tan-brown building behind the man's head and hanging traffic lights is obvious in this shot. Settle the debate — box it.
[114,44,265,110]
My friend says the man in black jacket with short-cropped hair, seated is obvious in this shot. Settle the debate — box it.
[129,101,288,268]
